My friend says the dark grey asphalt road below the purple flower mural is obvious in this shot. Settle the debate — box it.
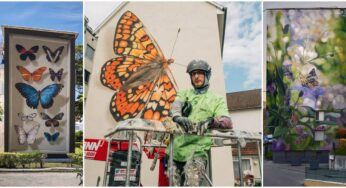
[263,160,305,186]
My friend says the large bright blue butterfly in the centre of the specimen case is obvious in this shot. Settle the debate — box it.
[15,83,64,109]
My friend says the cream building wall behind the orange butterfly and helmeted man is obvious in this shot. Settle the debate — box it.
[85,2,233,186]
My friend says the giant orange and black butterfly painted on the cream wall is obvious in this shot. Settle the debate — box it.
[101,11,176,121]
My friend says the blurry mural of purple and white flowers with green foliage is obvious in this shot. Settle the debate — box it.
[266,9,346,151]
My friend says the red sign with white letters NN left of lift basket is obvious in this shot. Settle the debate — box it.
[84,138,108,161]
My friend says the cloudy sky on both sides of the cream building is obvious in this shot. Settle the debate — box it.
[85,2,262,92]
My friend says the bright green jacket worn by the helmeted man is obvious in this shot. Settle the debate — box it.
[166,89,229,162]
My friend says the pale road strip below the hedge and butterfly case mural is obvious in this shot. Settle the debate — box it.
[0,172,79,187]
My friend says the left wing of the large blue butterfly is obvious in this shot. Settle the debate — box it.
[15,83,40,109]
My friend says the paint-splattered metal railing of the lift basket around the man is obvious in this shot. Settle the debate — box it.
[103,119,262,186]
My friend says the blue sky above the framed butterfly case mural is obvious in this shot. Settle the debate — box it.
[0,2,83,44]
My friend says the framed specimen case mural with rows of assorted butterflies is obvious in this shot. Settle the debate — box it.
[4,26,76,154]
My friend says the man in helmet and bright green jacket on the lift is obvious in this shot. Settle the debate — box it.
[171,60,232,186]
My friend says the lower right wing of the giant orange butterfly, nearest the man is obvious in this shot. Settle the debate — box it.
[141,73,177,121]
